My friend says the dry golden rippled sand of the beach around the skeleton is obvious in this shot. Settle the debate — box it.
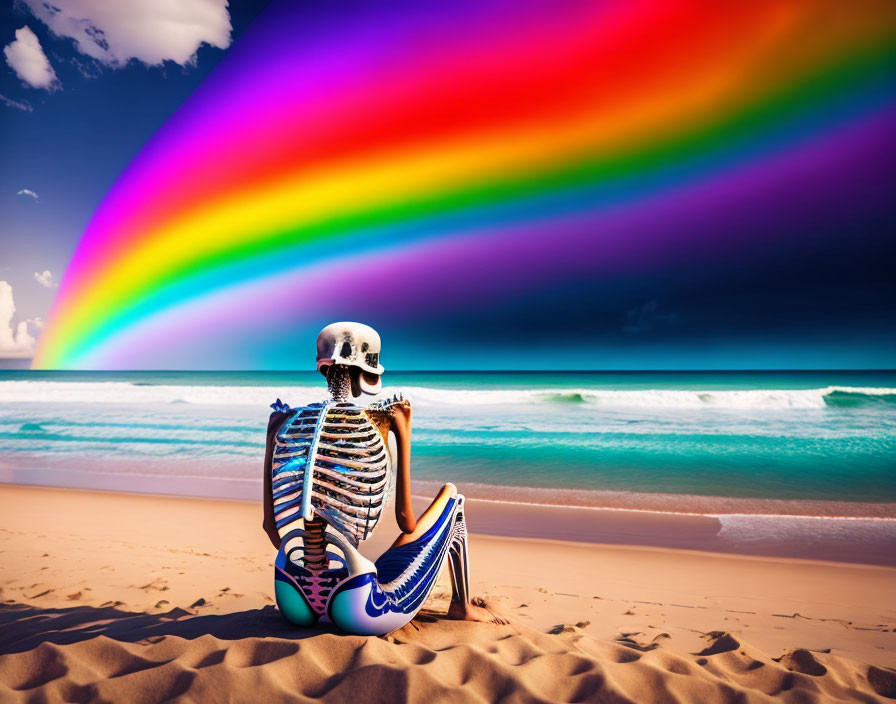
[0,485,896,704]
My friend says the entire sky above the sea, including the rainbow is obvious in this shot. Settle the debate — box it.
[0,0,896,369]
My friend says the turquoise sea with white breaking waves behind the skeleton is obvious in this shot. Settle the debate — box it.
[0,371,896,502]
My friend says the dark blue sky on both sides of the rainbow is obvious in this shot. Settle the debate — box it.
[0,2,896,369]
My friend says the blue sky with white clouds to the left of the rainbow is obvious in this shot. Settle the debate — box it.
[0,0,266,366]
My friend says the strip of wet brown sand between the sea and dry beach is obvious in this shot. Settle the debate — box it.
[0,478,896,567]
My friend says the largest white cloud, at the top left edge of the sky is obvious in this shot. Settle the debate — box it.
[23,0,232,68]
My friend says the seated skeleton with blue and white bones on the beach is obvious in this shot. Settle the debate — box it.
[268,323,480,634]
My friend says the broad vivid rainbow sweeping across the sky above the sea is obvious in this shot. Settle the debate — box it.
[34,0,896,368]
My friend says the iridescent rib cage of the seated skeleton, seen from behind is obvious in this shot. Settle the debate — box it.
[271,401,391,546]
